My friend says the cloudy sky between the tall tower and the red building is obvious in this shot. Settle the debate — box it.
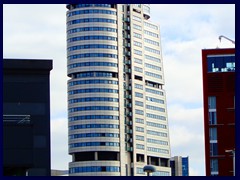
[151,4,235,175]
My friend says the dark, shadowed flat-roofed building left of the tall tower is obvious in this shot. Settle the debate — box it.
[3,59,52,176]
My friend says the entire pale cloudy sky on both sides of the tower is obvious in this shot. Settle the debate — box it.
[3,4,235,176]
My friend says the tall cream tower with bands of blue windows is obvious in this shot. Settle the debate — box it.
[67,4,171,176]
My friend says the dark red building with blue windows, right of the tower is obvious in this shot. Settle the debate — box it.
[202,49,235,176]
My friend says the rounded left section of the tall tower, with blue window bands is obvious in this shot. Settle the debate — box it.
[67,4,120,175]
